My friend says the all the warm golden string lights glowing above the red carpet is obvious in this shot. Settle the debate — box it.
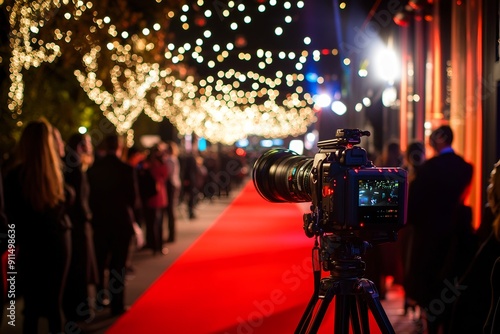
[4,0,316,144]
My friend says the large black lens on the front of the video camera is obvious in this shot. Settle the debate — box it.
[253,149,314,202]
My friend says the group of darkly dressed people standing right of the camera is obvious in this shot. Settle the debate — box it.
[365,125,500,334]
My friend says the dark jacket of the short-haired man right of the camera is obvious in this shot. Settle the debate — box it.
[405,152,474,306]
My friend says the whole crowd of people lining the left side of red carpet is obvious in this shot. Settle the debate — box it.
[0,118,248,334]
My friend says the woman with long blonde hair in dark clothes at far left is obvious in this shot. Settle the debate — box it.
[4,119,71,333]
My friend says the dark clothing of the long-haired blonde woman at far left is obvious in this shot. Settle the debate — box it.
[4,167,71,328]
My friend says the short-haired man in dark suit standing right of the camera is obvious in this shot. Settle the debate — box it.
[405,126,474,333]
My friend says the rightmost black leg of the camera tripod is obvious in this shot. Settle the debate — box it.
[356,279,395,334]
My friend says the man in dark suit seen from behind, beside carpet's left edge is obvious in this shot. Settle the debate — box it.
[87,135,139,315]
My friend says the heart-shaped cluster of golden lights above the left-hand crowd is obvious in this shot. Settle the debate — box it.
[75,43,194,145]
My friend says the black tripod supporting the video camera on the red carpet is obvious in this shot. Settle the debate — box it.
[295,236,394,334]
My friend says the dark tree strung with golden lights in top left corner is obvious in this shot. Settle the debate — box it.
[0,0,185,152]
